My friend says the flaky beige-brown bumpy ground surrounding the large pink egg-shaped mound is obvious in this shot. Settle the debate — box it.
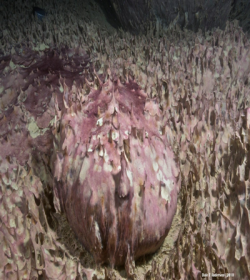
[0,1,250,279]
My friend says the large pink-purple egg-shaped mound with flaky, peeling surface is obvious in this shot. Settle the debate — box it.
[54,76,179,265]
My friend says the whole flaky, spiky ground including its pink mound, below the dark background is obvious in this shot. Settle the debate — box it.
[0,1,250,279]
